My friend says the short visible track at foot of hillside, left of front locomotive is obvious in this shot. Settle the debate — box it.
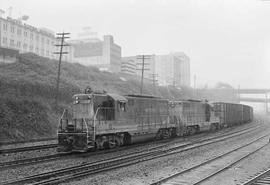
[0,144,57,154]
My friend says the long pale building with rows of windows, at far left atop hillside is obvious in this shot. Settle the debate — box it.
[0,17,57,59]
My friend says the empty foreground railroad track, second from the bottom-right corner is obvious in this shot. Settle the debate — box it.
[151,134,270,185]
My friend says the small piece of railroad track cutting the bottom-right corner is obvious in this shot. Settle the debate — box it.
[241,168,270,185]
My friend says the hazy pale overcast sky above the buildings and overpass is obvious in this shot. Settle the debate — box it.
[0,0,270,88]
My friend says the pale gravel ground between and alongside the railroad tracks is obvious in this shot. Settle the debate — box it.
[0,117,270,185]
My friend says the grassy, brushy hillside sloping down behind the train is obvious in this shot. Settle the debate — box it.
[0,54,236,141]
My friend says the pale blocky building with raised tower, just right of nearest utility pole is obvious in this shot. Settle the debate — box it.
[68,35,121,72]
